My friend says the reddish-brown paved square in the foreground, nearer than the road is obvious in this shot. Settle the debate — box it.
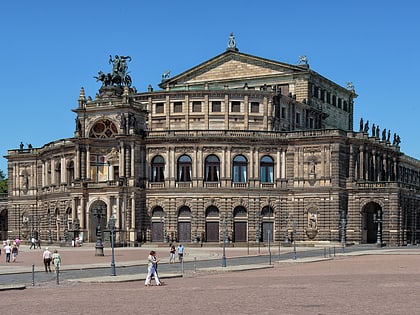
[0,250,420,315]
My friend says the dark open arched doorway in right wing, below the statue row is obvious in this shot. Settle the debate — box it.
[362,201,382,244]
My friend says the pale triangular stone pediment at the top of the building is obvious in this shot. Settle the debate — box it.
[161,51,308,87]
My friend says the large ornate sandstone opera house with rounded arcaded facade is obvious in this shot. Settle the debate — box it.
[7,37,420,245]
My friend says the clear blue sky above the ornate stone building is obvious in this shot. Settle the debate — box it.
[0,0,420,173]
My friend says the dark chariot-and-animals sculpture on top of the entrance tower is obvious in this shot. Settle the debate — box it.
[94,55,132,87]
